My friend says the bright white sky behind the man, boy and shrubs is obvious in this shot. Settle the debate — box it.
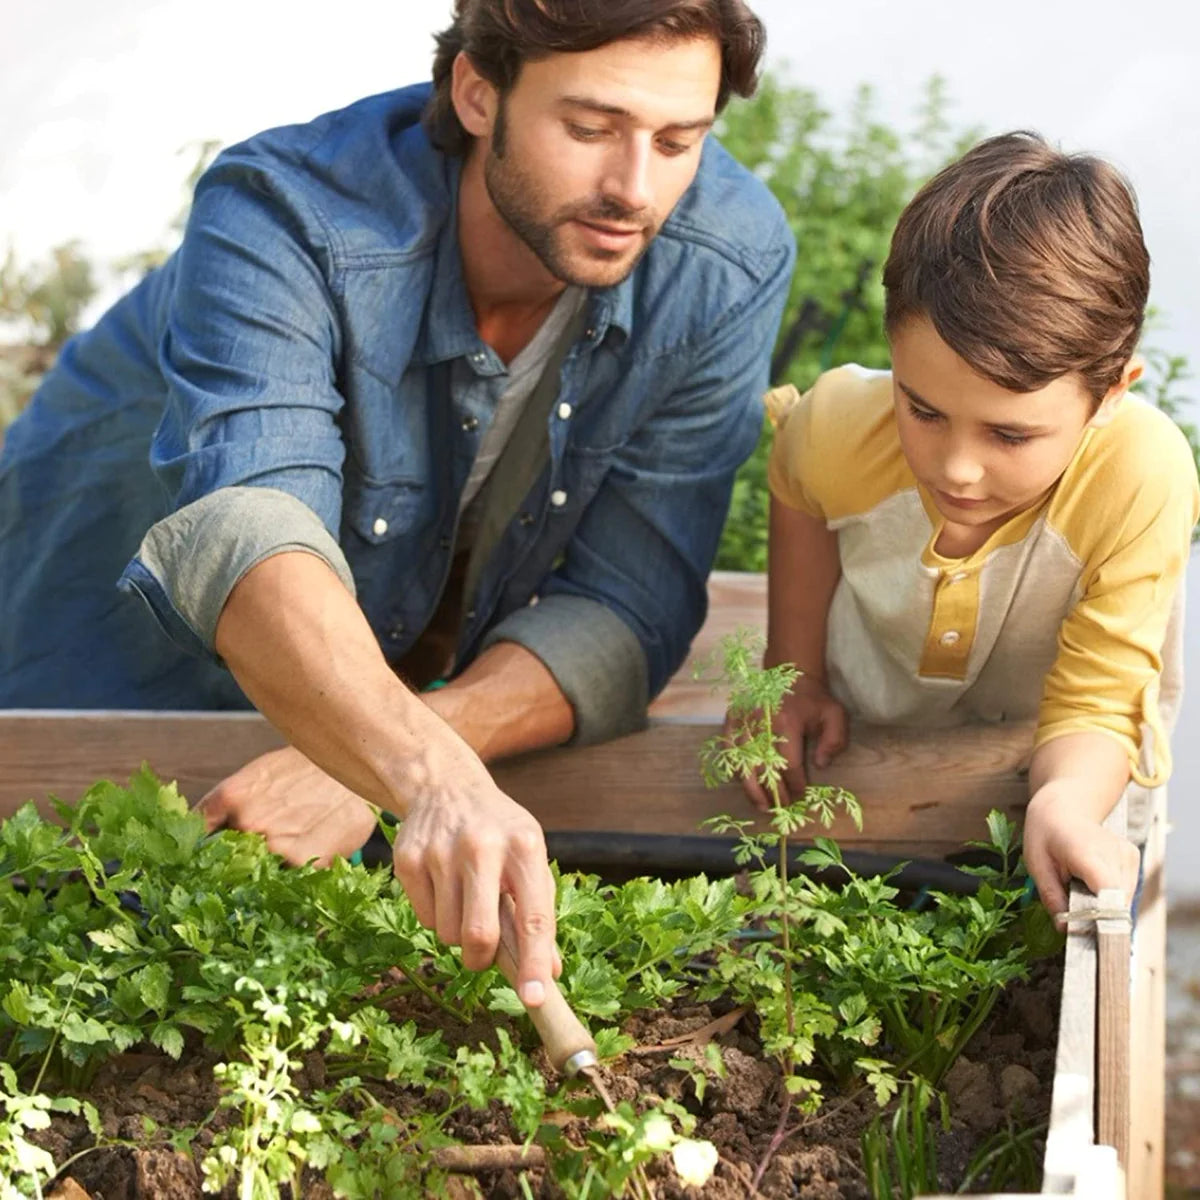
[7,0,1200,889]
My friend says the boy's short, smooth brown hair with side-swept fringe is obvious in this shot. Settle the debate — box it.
[883,132,1150,403]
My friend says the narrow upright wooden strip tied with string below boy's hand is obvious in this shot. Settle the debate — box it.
[1096,888,1130,1168]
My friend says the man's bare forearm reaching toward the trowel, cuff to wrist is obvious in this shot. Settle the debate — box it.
[216,552,480,815]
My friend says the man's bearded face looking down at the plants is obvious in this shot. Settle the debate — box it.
[475,37,721,287]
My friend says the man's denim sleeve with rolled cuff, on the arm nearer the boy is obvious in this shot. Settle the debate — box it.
[487,215,794,744]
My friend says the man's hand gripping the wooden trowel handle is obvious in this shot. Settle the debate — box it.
[392,770,562,1008]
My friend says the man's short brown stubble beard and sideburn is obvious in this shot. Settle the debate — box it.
[484,107,658,288]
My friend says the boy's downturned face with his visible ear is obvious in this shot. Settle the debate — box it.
[892,317,1130,538]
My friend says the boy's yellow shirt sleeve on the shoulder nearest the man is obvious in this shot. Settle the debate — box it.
[766,364,916,521]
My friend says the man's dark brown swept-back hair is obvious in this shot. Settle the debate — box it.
[424,0,766,155]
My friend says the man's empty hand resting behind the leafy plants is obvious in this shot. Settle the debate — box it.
[197,746,376,866]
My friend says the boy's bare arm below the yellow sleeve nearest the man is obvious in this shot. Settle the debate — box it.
[766,497,841,683]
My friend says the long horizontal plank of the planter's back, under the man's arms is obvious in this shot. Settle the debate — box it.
[0,713,1030,858]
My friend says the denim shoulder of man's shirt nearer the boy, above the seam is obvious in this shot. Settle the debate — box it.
[652,137,796,283]
